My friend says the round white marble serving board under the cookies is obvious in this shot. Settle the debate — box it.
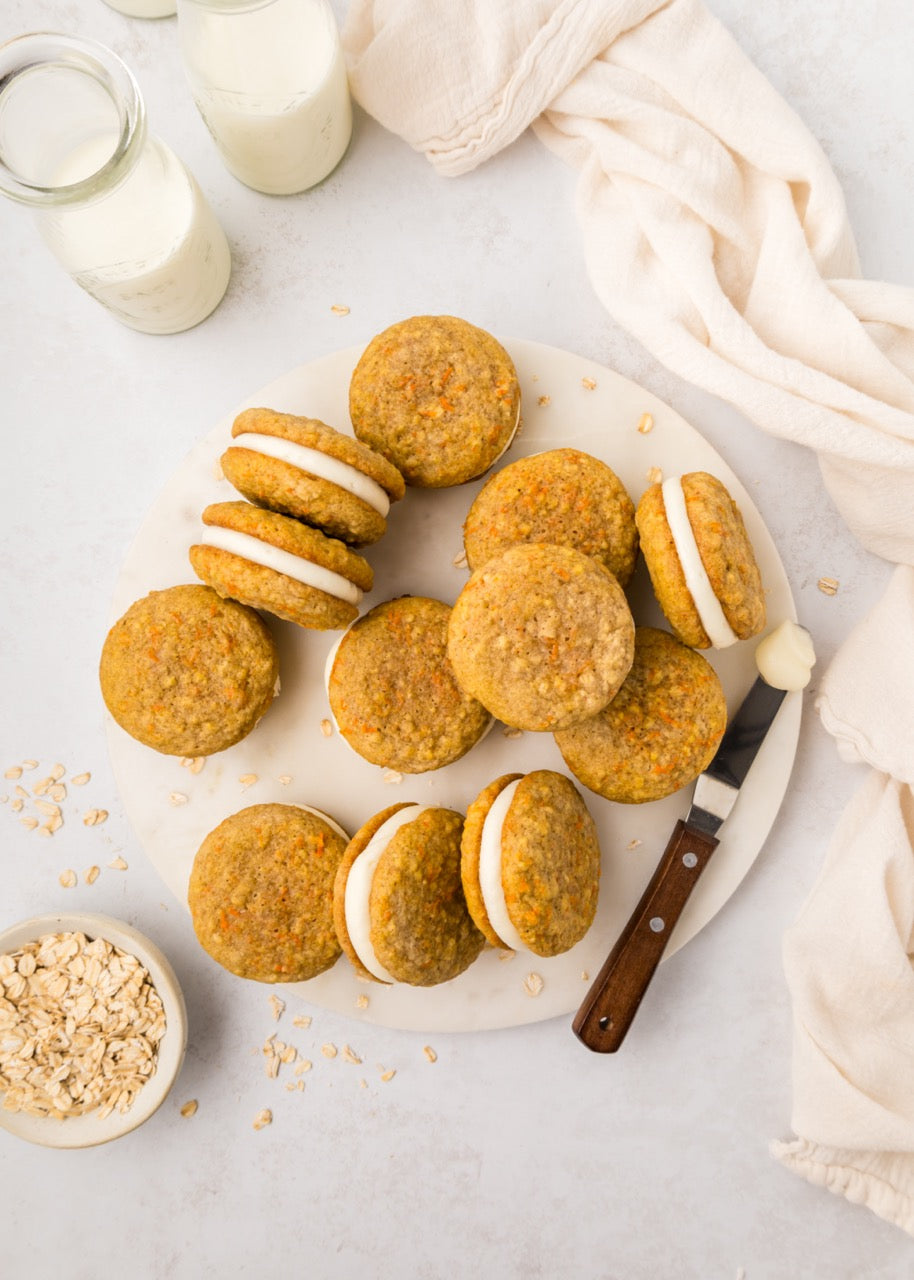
[108,339,801,1032]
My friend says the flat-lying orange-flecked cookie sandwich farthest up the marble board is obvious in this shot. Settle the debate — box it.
[349,316,521,489]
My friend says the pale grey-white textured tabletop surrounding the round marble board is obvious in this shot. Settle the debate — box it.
[0,0,914,1280]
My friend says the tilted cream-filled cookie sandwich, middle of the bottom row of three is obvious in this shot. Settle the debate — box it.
[333,804,485,987]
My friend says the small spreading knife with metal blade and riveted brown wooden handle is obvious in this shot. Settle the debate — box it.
[572,676,786,1053]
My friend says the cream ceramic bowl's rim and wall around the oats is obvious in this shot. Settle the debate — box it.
[0,914,187,1148]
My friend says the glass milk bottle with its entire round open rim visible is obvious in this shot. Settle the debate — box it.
[0,32,230,333]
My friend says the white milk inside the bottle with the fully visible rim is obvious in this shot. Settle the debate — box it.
[38,137,230,333]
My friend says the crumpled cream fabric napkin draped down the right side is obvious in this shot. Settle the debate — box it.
[343,0,914,1233]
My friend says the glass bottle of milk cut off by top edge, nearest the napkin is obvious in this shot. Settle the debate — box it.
[178,0,352,196]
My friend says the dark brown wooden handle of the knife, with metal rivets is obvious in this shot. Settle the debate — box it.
[571,819,718,1053]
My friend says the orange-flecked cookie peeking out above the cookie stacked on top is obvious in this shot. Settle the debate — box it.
[463,449,637,586]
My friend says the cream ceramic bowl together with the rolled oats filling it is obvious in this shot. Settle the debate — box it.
[0,915,187,1147]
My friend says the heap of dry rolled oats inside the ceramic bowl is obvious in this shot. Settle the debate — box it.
[0,931,165,1119]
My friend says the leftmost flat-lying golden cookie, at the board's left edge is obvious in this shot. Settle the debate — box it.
[99,584,279,756]
